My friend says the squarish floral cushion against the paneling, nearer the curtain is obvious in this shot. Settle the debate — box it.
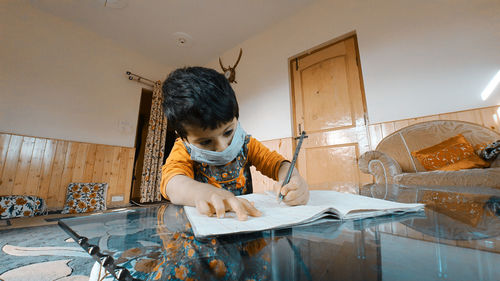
[62,182,108,214]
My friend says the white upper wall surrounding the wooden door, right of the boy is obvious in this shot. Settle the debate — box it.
[207,0,500,140]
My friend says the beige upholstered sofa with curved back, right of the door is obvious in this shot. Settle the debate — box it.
[358,120,500,188]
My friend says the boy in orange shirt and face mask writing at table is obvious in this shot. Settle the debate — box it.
[161,67,309,220]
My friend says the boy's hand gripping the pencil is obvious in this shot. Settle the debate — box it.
[273,171,309,206]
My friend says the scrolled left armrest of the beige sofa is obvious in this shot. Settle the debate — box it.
[358,150,402,184]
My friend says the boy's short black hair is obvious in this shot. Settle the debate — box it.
[162,67,239,139]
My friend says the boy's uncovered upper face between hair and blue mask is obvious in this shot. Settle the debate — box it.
[184,117,238,152]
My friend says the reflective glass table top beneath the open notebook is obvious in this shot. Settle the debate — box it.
[59,185,500,280]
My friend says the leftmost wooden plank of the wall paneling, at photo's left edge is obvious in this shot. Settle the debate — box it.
[0,136,23,195]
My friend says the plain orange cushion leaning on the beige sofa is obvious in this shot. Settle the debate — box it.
[411,134,489,171]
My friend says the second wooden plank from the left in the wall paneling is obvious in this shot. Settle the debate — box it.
[24,138,47,195]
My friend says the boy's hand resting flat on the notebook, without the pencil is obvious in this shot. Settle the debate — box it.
[195,189,262,220]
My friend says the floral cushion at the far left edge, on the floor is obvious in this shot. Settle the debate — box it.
[0,195,47,219]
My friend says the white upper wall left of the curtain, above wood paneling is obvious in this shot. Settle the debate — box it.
[0,1,170,147]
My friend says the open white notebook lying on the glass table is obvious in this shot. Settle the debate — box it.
[184,190,424,238]
